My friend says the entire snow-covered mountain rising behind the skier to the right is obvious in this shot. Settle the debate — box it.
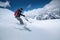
[24,0,60,20]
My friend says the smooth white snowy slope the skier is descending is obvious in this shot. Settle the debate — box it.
[0,8,60,40]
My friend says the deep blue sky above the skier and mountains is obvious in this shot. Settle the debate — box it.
[0,0,51,11]
